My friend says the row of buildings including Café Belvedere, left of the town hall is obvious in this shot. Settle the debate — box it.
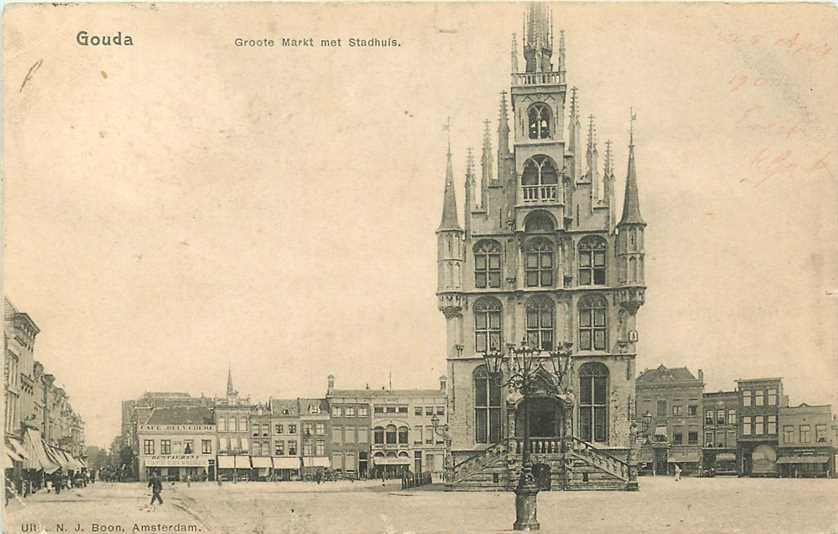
[121,373,447,480]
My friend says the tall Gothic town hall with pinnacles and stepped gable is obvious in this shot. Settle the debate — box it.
[436,4,646,489]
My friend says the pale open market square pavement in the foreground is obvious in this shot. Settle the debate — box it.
[5,477,838,534]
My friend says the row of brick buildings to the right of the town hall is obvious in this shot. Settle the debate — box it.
[636,365,838,477]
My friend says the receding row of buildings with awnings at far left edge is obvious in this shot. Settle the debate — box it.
[0,298,86,491]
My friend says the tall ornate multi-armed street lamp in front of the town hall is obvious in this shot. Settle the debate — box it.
[483,337,573,531]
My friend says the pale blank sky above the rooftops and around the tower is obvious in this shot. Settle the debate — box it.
[3,4,838,446]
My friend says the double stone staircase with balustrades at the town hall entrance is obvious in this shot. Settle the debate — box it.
[448,437,629,491]
